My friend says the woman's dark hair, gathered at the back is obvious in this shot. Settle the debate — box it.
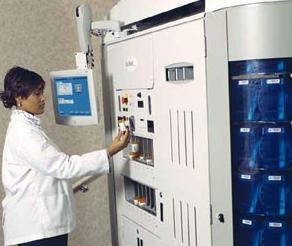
[0,67,45,108]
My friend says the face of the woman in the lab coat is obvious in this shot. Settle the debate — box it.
[16,87,46,115]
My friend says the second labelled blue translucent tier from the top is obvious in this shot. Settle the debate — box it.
[231,123,292,170]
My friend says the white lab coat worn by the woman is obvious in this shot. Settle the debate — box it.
[2,110,109,245]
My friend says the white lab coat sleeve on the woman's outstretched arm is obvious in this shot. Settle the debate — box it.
[21,127,109,179]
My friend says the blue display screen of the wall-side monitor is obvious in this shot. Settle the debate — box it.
[54,76,91,116]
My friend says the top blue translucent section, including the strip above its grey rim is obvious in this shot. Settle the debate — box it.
[229,58,292,121]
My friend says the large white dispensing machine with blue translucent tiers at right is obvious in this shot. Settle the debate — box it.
[73,0,292,246]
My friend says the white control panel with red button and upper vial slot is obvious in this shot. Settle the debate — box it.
[116,90,155,166]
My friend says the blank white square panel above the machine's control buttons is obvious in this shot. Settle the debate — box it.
[107,36,153,89]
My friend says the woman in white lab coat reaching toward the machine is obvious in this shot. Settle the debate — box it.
[1,67,129,246]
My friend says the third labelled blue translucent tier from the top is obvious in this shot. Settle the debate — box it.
[233,172,292,215]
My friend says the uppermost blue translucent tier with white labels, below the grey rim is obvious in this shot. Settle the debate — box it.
[230,77,292,121]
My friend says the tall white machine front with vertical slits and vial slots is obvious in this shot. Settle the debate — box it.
[105,13,211,246]
